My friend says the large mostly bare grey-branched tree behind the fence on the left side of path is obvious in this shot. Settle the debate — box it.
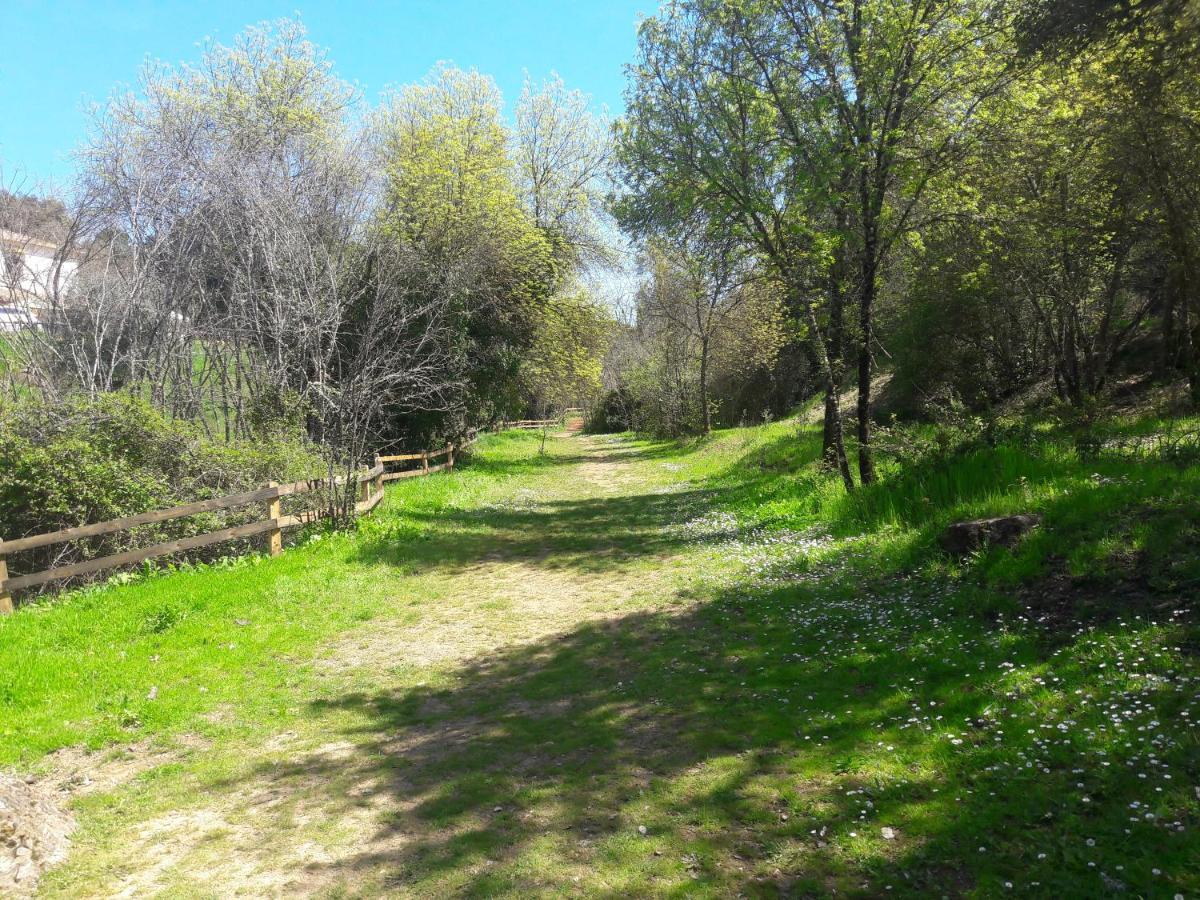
[25,22,452,515]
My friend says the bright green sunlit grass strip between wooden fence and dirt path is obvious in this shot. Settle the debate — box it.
[0,436,556,764]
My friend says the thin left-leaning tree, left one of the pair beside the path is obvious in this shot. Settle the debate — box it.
[617,0,853,490]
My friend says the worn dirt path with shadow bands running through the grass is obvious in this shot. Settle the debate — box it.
[46,434,697,896]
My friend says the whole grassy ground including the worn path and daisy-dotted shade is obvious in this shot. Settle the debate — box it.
[0,422,1200,896]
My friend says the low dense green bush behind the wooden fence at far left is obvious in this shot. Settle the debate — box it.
[0,395,322,592]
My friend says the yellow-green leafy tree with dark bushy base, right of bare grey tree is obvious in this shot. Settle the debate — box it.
[376,67,607,440]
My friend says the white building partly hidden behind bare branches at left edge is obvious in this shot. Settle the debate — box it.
[0,228,79,331]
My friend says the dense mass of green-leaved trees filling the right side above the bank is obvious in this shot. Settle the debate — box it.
[617,0,1200,487]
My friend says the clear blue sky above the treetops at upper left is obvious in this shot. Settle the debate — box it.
[0,0,658,190]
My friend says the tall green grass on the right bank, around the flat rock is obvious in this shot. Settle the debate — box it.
[686,410,1200,588]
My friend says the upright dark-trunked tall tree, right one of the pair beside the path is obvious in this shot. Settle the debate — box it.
[726,0,1012,482]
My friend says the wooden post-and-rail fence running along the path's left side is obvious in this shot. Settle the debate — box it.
[0,437,475,616]
